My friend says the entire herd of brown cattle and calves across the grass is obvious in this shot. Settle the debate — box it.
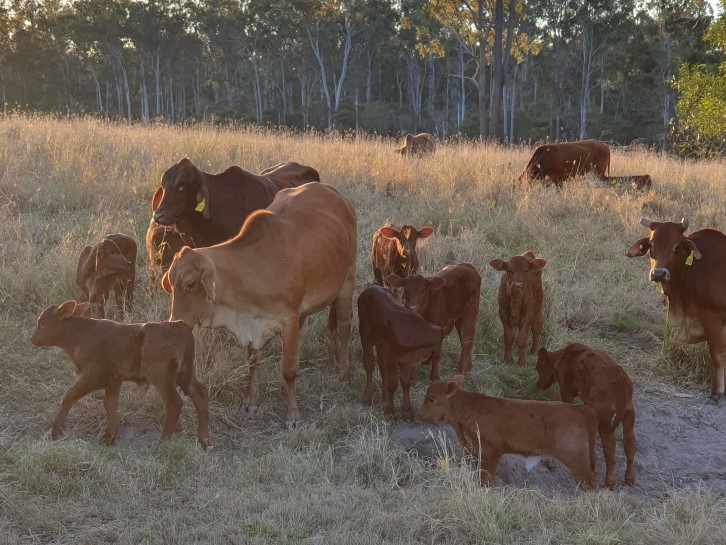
[25,134,726,490]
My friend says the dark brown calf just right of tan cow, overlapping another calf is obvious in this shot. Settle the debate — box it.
[358,285,451,420]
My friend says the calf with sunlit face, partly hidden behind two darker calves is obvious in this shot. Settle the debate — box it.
[371,223,434,286]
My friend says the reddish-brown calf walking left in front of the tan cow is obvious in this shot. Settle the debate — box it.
[30,301,209,449]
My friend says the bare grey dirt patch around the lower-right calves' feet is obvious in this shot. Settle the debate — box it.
[393,387,726,498]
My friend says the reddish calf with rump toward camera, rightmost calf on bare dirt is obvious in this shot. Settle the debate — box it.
[537,344,635,488]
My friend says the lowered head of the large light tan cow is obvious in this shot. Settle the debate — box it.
[161,246,217,327]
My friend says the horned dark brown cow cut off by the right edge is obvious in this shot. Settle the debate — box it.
[626,218,726,405]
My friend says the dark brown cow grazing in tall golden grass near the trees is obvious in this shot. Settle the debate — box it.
[519,140,610,187]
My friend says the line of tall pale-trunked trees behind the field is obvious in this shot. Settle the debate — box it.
[0,0,726,151]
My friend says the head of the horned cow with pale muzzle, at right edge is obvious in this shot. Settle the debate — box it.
[626,218,703,286]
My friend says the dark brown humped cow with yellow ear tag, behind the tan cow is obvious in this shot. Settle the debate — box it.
[154,159,320,247]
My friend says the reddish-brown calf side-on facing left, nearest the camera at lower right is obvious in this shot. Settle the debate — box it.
[419,375,597,490]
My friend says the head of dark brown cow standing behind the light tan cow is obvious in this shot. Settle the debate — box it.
[151,158,209,225]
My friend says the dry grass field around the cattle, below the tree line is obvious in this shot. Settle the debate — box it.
[0,117,726,545]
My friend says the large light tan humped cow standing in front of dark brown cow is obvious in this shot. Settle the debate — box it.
[162,183,357,427]
